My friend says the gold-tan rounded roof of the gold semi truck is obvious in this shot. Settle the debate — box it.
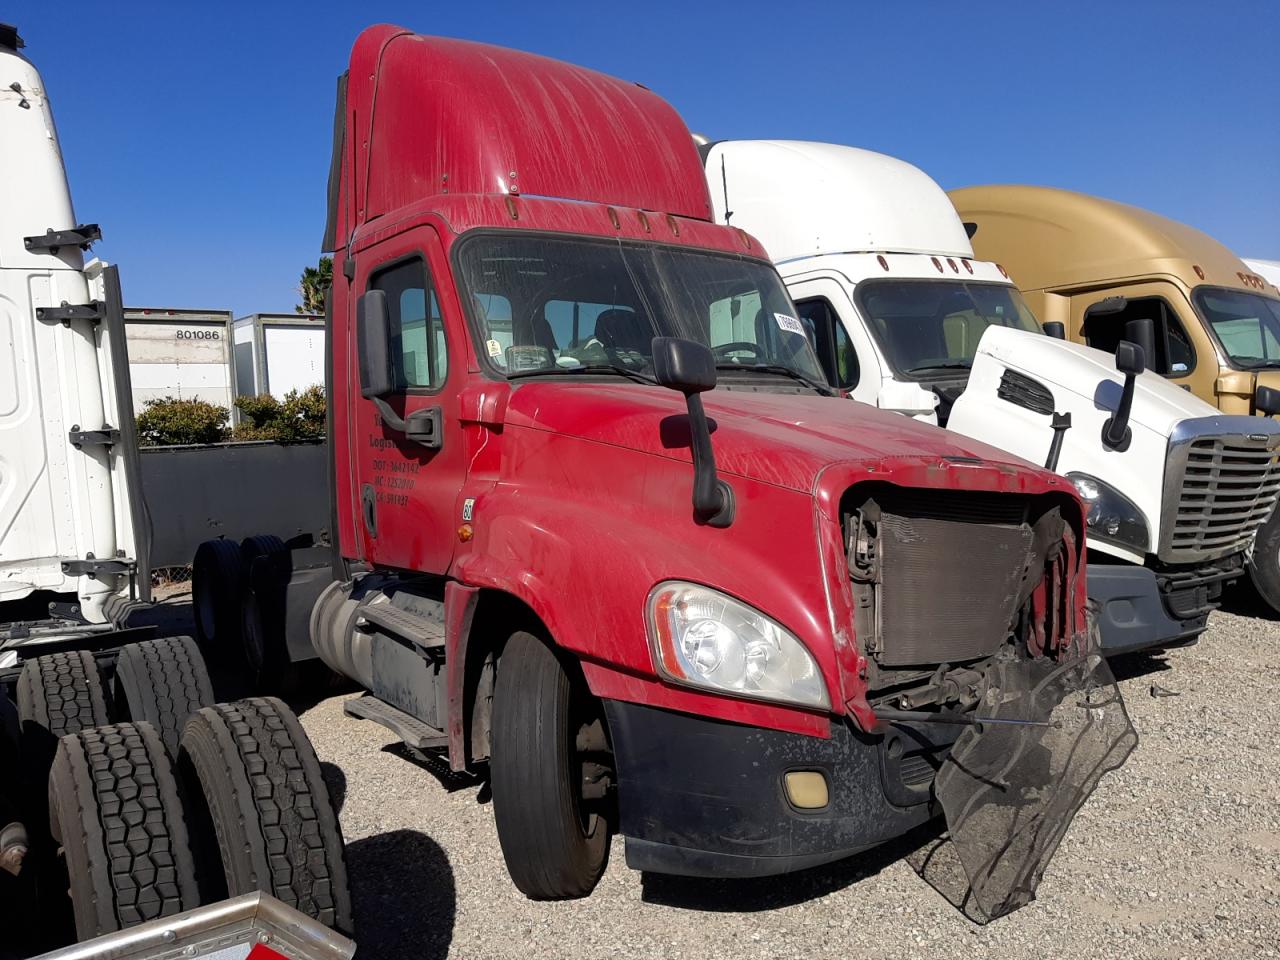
[951,186,1266,291]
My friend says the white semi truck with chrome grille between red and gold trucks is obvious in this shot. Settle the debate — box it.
[700,141,1280,653]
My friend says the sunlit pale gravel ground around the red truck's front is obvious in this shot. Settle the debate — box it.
[302,601,1280,960]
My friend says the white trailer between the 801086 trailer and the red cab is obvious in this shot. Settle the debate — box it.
[234,314,325,399]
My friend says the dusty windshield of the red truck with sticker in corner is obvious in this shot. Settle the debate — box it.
[458,234,827,389]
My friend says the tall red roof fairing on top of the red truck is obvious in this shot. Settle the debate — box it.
[324,24,710,256]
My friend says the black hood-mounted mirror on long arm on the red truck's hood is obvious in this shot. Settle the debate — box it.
[652,337,733,526]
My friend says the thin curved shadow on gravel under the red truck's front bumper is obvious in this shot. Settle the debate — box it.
[641,819,946,913]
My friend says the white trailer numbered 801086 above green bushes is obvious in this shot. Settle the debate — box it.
[124,307,236,413]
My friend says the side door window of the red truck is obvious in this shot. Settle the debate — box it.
[369,257,449,390]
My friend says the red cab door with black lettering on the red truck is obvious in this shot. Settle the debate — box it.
[348,225,466,573]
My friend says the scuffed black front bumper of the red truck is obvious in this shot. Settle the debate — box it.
[605,700,963,877]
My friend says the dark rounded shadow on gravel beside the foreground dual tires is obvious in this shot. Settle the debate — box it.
[347,829,457,960]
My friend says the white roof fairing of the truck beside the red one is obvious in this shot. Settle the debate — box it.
[703,140,973,262]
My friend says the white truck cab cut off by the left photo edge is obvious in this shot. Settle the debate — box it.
[0,24,148,647]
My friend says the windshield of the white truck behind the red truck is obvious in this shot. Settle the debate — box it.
[856,279,1041,379]
